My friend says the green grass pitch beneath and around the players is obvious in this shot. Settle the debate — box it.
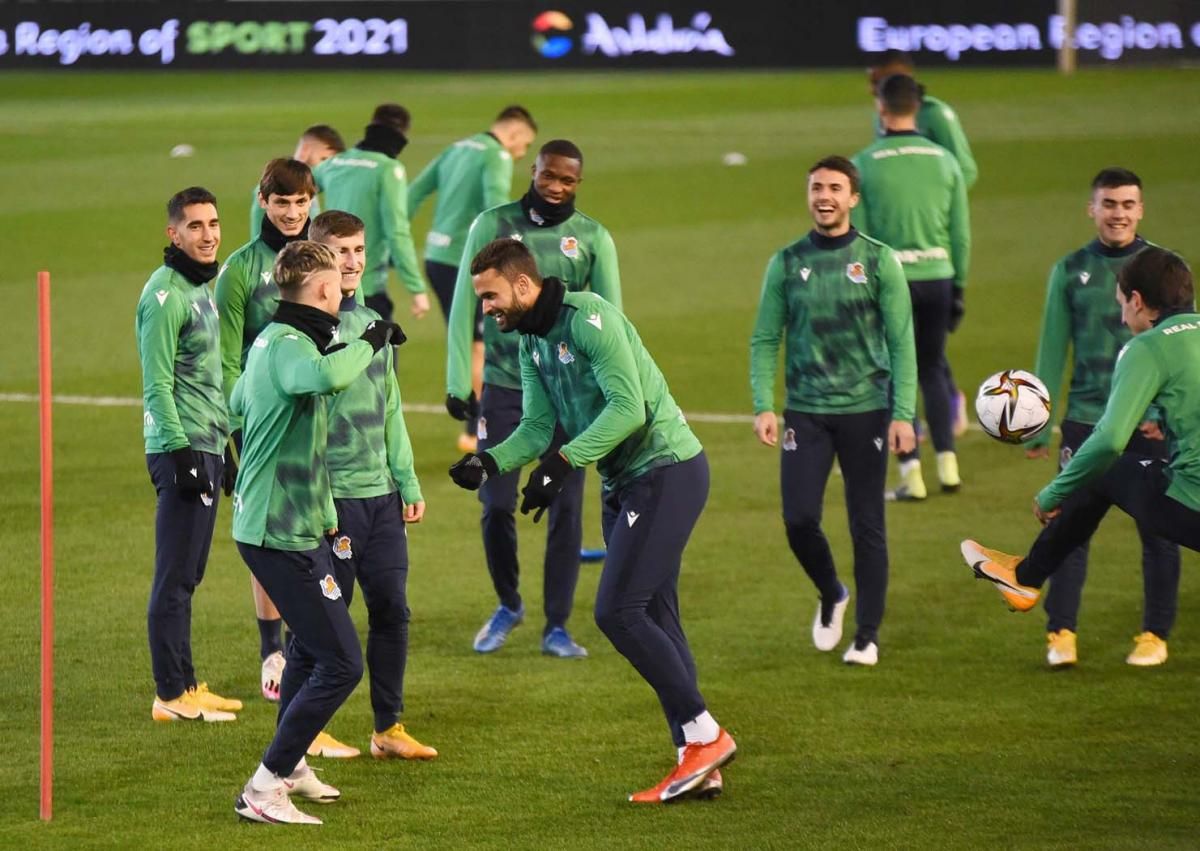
[0,71,1200,849]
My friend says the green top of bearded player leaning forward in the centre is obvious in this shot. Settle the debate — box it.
[487,293,703,490]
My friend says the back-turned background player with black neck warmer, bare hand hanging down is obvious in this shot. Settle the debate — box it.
[314,103,430,320]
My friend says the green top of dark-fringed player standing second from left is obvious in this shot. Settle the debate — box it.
[216,239,280,417]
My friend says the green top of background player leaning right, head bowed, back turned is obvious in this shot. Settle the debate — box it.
[408,133,512,266]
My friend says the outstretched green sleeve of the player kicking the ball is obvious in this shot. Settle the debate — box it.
[1038,337,1166,511]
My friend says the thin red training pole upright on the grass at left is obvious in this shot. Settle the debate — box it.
[37,271,54,821]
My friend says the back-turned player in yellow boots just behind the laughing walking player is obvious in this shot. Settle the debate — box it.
[852,74,971,501]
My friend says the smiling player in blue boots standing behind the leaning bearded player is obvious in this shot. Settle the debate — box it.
[446,139,620,658]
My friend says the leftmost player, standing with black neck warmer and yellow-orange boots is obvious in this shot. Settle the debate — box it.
[134,186,241,721]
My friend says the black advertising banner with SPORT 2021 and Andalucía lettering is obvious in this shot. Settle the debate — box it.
[0,0,1200,71]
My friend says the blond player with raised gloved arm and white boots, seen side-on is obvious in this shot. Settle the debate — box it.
[230,240,403,825]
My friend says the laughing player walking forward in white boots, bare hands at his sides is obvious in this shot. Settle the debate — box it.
[750,156,917,665]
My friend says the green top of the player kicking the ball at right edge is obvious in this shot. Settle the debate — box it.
[1038,312,1200,511]
